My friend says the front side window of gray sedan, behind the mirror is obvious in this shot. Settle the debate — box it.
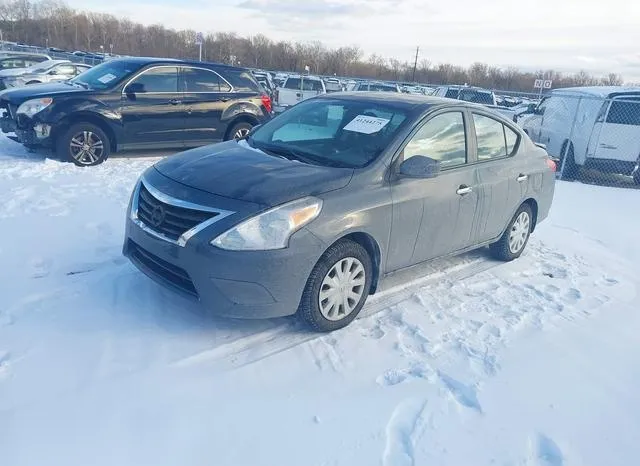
[403,112,464,169]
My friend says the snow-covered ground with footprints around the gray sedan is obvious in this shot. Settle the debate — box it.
[0,138,640,466]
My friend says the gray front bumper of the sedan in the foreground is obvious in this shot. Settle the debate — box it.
[123,173,325,318]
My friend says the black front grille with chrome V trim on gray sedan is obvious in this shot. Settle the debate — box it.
[138,184,218,241]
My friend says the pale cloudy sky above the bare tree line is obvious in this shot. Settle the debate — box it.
[71,0,640,81]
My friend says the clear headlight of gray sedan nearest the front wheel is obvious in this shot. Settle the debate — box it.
[211,197,322,251]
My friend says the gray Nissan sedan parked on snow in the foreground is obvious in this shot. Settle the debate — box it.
[124,92,555,331]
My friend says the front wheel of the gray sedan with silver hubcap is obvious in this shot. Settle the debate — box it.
[298,240,373,332]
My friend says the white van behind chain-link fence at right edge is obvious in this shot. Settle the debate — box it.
[518,86,640,184]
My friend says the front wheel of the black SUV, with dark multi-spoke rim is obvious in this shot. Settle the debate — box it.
[56,123,111,167]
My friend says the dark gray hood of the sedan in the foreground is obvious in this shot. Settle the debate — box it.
[155,141,353,206]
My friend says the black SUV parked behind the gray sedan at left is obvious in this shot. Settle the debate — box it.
[0,58,271,166]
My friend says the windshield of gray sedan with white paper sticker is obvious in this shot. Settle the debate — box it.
[247,99,407,168]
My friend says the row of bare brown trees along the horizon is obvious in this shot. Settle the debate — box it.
[0,0,623,92]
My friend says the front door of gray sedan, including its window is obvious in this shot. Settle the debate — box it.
[387,109,478,271]
